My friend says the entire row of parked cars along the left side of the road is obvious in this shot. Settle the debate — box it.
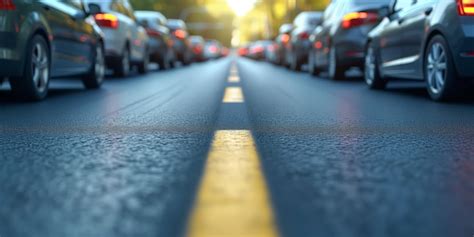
[0,0,228,100]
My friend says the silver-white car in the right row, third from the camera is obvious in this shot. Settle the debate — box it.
[285,12,323,71]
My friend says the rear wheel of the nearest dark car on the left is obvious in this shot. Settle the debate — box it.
[10,35,51,101]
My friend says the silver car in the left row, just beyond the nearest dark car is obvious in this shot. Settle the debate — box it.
[87,0,149,77]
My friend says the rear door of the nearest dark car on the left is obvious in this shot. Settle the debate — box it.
[40,0,82,76]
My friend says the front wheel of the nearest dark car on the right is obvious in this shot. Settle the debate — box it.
[364,43,387,89]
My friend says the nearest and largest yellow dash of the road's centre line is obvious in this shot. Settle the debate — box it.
[188,130,278,237]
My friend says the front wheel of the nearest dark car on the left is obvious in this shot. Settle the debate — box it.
[82,44,105,89]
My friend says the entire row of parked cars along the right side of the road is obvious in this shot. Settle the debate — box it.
[243,0,474,101]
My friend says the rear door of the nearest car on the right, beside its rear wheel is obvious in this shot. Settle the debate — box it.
[400,0,438,79]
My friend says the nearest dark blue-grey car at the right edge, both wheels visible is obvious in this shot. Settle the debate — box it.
[364,0,474,101]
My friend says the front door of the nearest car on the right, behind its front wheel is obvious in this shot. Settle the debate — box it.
[379,0,414,76]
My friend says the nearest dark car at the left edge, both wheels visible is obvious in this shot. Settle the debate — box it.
[0,0,105,100]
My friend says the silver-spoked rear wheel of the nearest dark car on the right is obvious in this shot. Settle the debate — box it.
[424,35,462,101]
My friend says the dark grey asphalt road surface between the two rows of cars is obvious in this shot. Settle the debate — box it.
[0,58,474,237]
